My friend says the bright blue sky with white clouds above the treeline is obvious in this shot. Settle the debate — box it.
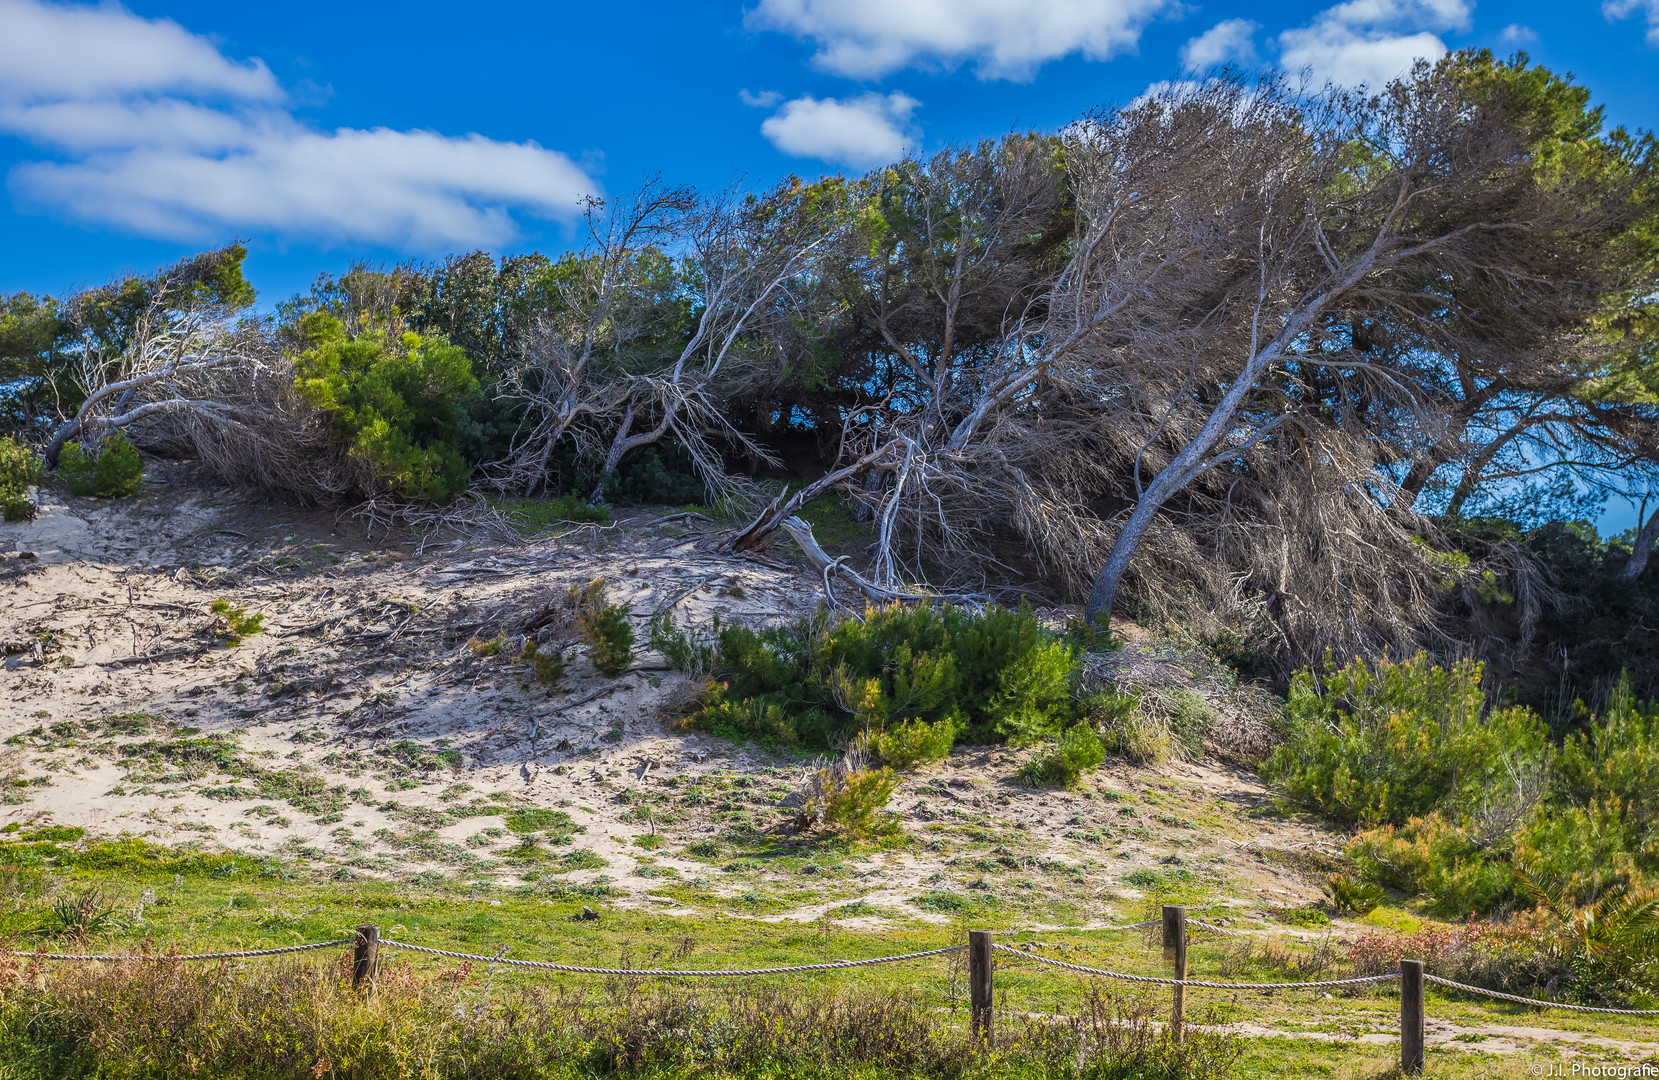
[0,0,1659,528]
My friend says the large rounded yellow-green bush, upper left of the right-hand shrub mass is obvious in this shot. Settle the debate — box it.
[1262,655,1546,825]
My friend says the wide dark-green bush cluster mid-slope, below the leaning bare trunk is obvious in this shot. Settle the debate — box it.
[666,604,1077,747]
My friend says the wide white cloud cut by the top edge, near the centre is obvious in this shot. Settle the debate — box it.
[747,0,1176,81]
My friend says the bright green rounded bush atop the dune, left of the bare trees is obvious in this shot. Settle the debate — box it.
[294,312,483,501]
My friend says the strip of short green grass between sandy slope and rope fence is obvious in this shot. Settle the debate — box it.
[0,849,1652,1080]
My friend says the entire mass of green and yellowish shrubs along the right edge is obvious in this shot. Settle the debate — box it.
[1287,657,1659,916]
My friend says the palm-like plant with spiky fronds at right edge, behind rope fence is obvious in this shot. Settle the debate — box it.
[1515,869,1659,992]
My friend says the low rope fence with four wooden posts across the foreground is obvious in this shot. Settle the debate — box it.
[10,904,1659,1073]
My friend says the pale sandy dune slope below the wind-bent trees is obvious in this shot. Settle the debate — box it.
[0,466,1339,919]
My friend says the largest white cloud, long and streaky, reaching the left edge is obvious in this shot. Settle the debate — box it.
[0,0,594,252]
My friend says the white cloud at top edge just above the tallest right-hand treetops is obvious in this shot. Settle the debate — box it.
[1279,0,1473,90]
